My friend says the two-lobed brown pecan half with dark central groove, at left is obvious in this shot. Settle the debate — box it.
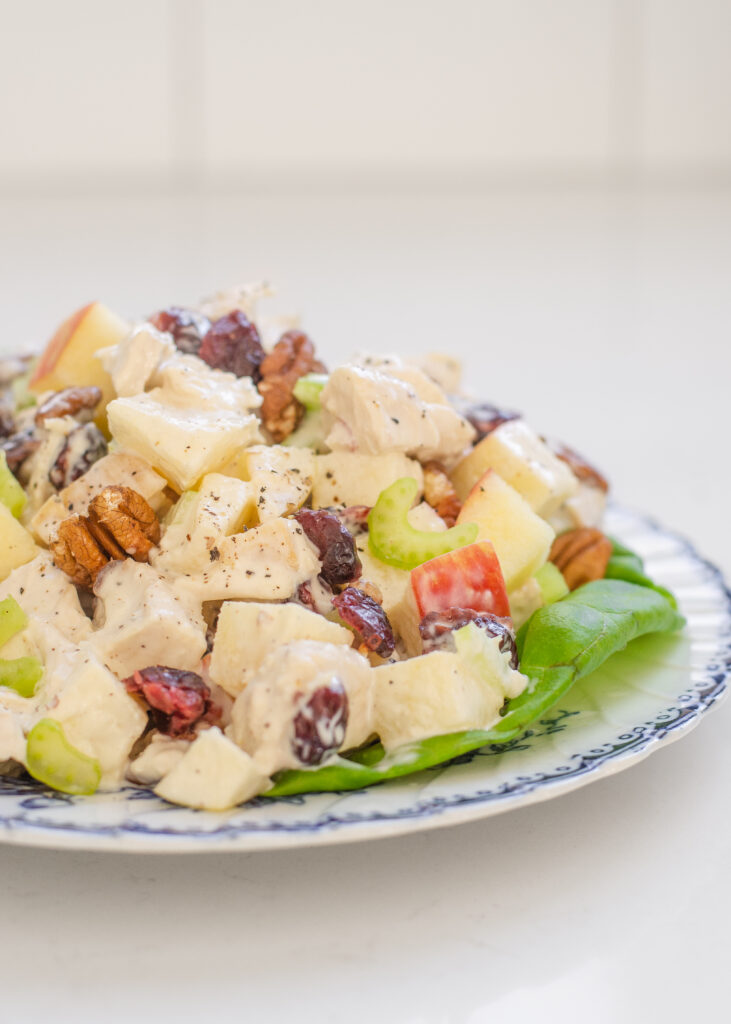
[49,486,160,587]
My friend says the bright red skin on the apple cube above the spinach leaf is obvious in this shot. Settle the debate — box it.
[411,541,510,618]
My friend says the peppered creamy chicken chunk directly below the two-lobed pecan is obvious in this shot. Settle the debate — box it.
[89,558,207,679]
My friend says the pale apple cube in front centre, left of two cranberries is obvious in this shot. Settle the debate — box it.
[209,601,353,697]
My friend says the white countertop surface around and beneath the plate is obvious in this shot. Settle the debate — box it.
[0,190,731,1024]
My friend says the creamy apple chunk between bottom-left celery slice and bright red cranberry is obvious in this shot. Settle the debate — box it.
[41,652,147,786]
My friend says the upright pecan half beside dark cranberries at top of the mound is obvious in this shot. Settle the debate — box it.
[259,331,323,442]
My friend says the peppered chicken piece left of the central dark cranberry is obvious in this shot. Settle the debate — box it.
[176,519,320,601]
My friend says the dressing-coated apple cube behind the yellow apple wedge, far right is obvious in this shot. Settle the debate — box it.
[452,420,578,516]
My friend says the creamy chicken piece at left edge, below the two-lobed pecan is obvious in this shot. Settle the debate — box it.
[0,552,91,643]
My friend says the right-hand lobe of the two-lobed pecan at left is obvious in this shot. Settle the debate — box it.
[89,485,160,562]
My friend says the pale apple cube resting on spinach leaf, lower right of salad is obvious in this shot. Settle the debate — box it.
[373,651,504,751]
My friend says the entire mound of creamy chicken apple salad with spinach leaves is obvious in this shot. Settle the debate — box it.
[0,286,683,811]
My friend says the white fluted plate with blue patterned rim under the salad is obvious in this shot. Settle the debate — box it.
[0,508,731,853]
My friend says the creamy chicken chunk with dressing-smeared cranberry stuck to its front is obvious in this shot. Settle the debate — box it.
[231,640,374,775]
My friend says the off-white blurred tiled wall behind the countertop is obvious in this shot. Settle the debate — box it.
[0,0,731,191]
